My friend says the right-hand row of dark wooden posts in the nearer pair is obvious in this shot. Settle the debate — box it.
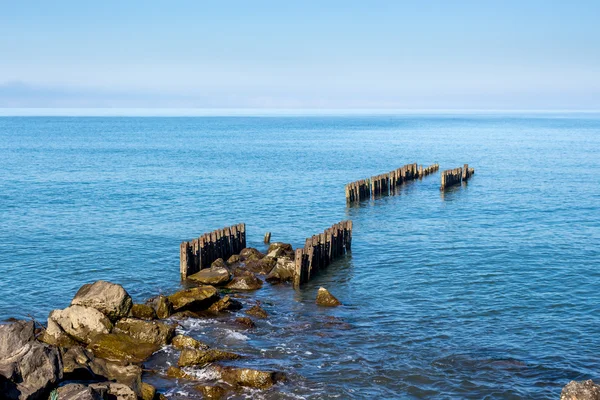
[294,221,352,287]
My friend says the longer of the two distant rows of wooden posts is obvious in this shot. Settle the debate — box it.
[346,163,440,203]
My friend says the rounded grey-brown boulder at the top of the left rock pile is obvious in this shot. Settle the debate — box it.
[71,281,133,322]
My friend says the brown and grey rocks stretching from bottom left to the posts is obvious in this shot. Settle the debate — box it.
[0,243,340,400]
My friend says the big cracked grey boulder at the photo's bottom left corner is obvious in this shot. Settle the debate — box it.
[0,321,63,400]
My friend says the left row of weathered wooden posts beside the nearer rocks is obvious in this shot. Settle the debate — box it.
[179,224,246,279]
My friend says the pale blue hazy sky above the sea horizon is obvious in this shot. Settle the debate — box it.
[0,0,600,110]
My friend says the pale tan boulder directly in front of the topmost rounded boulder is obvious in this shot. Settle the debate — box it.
[46,305,112,343]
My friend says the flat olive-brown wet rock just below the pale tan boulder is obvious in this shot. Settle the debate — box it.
[88,333,160,363]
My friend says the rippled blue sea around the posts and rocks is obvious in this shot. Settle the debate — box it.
[0,113,600,399]
